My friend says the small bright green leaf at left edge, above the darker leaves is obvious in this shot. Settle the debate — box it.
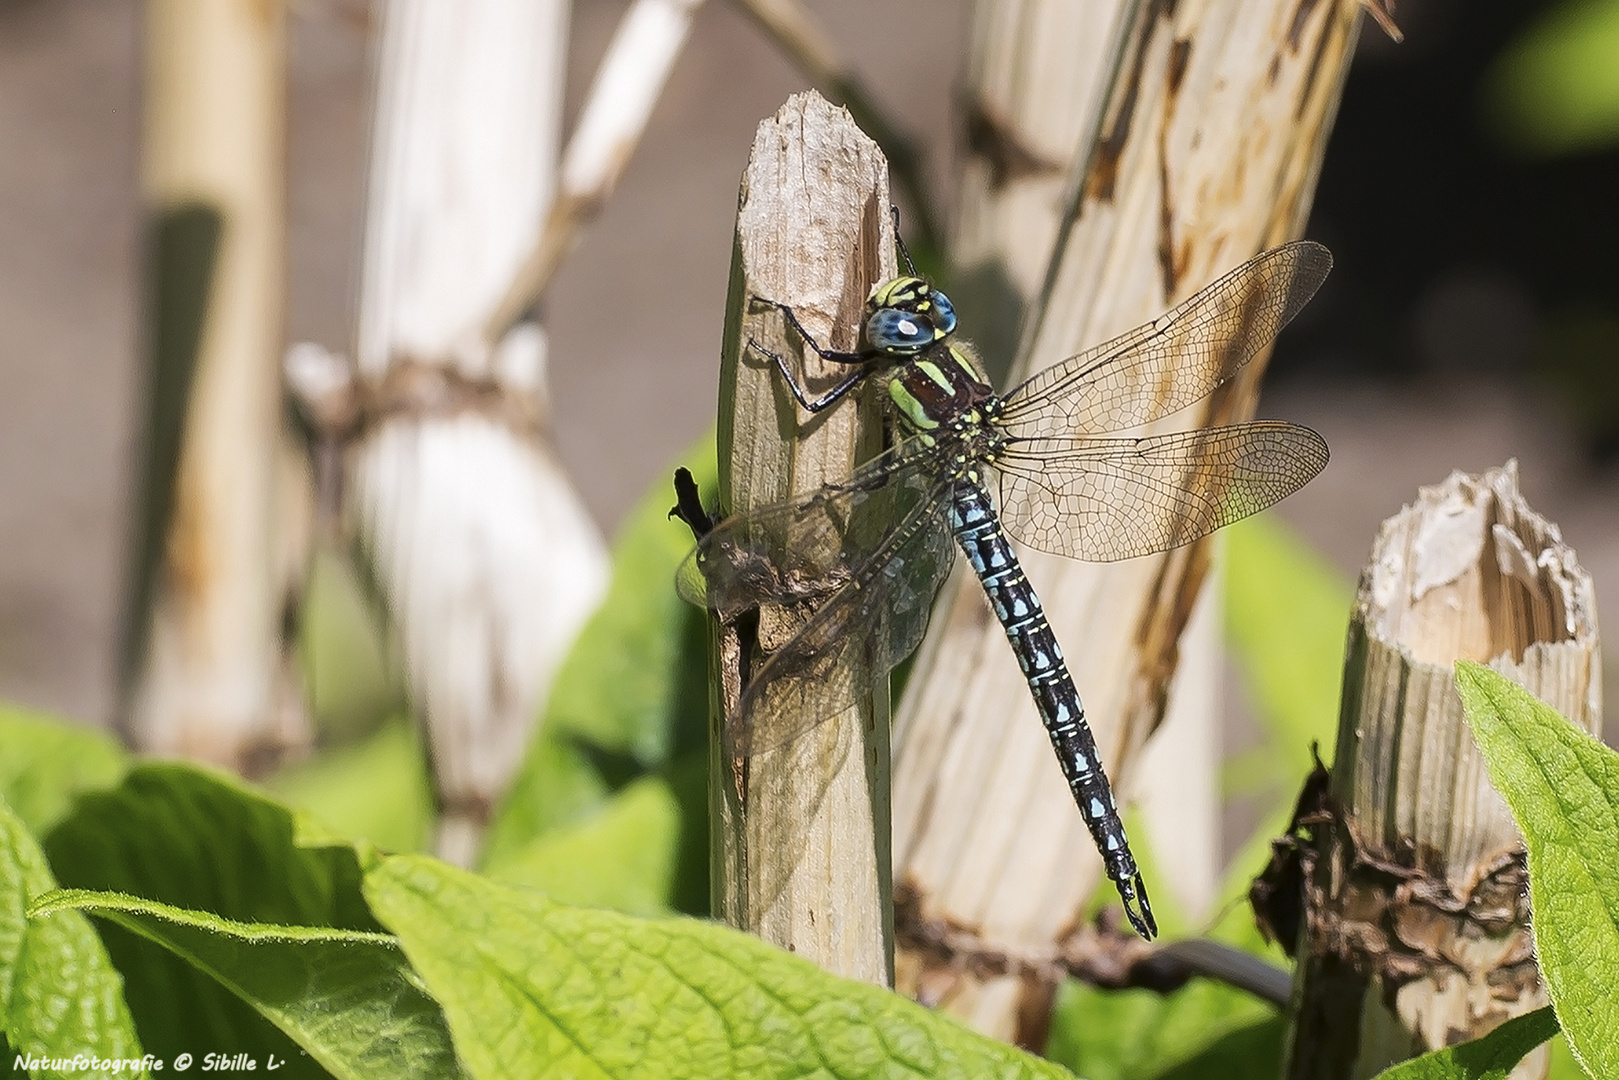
[0,704,130,836]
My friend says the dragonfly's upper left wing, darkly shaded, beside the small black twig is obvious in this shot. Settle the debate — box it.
[675,439,934,619]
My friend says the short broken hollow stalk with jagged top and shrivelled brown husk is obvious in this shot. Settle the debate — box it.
[1285,461,1601,1080]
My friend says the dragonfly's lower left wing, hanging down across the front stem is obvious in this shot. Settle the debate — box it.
[725,473,954,756]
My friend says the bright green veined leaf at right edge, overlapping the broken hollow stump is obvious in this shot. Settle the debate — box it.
[1455,661,1619,1077]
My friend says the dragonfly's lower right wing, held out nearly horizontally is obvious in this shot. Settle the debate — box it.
[996,421,1328,562]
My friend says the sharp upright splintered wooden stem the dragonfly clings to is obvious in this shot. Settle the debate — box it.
[711,92,895,984]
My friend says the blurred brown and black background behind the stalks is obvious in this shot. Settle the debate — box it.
[0,0,1619,761]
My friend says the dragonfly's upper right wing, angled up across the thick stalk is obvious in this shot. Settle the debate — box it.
[1001,240,1332,439]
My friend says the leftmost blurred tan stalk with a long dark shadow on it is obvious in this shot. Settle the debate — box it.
[120,0,308,772]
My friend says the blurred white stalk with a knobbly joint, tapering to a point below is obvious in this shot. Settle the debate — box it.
[348,0,607,865]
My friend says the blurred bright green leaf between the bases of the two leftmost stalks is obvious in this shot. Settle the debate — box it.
[264,717,432,852]
